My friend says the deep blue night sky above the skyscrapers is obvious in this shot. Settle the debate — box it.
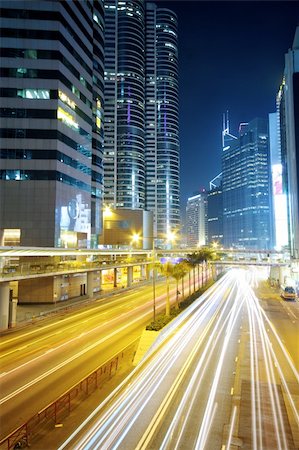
[155,0,299,211]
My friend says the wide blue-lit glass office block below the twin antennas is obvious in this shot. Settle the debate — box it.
[222,119,272,249]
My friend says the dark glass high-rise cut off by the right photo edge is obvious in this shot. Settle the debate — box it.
[277,27,299,258]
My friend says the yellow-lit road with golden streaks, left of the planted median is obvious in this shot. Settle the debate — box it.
[0,281,185,438]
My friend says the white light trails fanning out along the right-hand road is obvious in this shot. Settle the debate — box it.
[58,269,298,450]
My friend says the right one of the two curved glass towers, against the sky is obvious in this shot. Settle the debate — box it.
[145,4,180,238]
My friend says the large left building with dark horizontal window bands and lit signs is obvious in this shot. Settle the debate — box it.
[0,0,104,247]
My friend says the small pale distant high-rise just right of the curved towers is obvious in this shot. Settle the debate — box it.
[186,192,208,247]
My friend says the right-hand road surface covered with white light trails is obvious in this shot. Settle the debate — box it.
[59,269,299,450]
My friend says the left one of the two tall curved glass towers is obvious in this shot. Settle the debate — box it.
[104,0,145,209]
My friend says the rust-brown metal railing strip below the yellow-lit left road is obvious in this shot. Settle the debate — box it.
[0,344,135,450]
